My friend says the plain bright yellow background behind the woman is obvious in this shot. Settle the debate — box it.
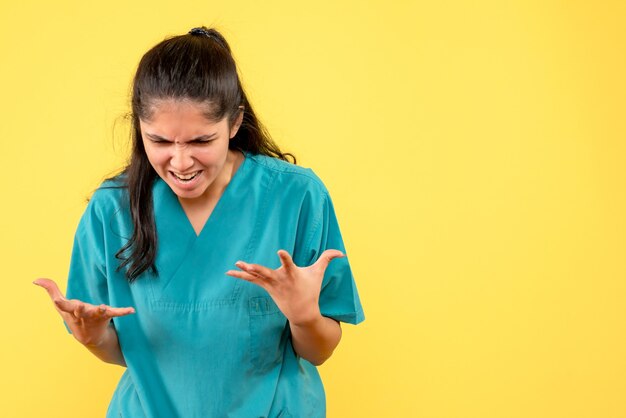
[0,0,626,418]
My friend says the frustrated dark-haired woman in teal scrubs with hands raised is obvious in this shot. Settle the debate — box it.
[35,27,364,418]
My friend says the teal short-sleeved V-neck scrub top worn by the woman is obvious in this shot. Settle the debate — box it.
[67,153,364,418]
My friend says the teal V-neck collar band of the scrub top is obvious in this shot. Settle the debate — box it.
[154,151,250,241]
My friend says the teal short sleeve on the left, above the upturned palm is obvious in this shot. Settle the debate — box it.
[66,196,109,332]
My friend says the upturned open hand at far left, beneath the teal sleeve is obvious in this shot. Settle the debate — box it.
[33,279,135,346]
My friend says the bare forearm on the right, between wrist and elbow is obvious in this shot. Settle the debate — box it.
[290,315,341,366]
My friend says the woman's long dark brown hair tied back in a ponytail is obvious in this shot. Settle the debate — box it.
[115,26,296,282]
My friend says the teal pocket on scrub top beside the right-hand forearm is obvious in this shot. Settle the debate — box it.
[248,296,289,374]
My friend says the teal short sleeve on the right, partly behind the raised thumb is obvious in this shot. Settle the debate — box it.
[309,193,365,325]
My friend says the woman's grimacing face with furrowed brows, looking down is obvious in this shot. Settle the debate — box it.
[139,100,243,199]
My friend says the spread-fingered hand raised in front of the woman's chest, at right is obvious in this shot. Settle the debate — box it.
[226,250,344,325]
